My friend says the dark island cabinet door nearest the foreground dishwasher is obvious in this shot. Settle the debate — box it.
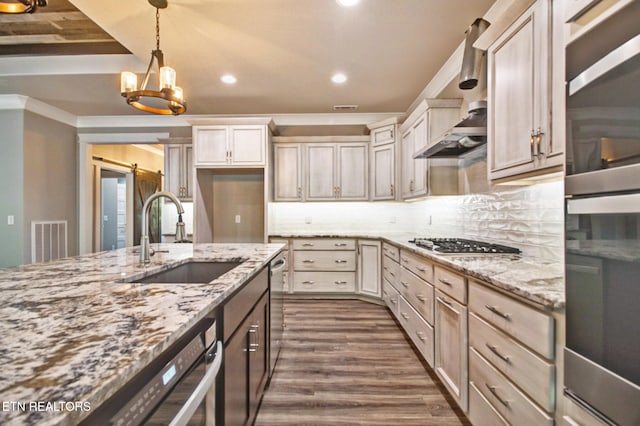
[224,319,250,426]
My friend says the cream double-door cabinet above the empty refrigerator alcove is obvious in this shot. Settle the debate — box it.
[193,125,267,167]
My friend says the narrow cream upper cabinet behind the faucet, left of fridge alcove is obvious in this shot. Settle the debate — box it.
[164,144,193,201]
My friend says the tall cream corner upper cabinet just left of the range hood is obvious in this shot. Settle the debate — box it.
[367,118,398,201]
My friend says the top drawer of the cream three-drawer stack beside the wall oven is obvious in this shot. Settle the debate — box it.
[469,281,554,359]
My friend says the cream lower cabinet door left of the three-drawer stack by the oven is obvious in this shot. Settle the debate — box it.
[435,290,468,412]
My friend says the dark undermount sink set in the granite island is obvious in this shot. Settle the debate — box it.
[130,262,242,284]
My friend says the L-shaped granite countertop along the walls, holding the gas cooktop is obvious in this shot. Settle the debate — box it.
[271,233,565,310]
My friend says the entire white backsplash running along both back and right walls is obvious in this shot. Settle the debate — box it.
[269,181,564,260]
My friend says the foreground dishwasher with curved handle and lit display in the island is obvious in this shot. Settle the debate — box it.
[81,316,223,426]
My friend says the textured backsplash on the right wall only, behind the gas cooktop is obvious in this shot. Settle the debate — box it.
[414,181,564,260]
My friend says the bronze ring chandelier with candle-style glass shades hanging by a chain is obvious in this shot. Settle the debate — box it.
[120,0,187,115]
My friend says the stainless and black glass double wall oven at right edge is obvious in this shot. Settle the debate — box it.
[564,0,640,425]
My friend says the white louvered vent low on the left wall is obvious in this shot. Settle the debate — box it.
[31,220,67,263]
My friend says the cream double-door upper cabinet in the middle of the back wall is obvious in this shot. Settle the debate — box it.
[304,143,369,201]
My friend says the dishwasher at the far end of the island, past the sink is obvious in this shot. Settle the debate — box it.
[269,252,286,377]
